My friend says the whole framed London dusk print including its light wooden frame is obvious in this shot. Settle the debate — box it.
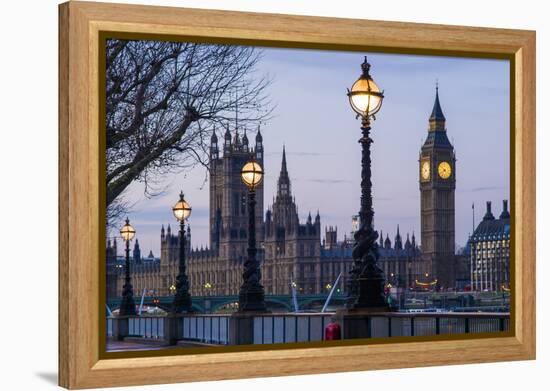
[59,2,535,388]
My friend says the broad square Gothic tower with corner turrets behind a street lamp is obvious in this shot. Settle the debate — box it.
[210,128,264,261]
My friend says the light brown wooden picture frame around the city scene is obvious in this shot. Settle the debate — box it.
[59,2,535,389]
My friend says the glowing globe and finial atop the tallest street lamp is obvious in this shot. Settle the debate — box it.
[348,56,384,118]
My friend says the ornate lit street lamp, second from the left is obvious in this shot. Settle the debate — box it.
[172,191,191,313]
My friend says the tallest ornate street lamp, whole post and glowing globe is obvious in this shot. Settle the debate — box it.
[346,56,386,309]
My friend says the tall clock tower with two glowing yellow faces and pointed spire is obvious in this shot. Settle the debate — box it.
[417,87,456,287]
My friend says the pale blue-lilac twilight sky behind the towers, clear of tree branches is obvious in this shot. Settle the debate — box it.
[111,48,510,256]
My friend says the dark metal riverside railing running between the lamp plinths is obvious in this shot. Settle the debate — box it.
[107,312,510,345]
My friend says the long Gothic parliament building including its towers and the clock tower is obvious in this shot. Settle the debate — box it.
[107,90,470,297]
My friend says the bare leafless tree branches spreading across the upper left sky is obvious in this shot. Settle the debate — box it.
[106,40,272,227]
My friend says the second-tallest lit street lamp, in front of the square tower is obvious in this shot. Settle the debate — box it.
[239,160,267,312]
